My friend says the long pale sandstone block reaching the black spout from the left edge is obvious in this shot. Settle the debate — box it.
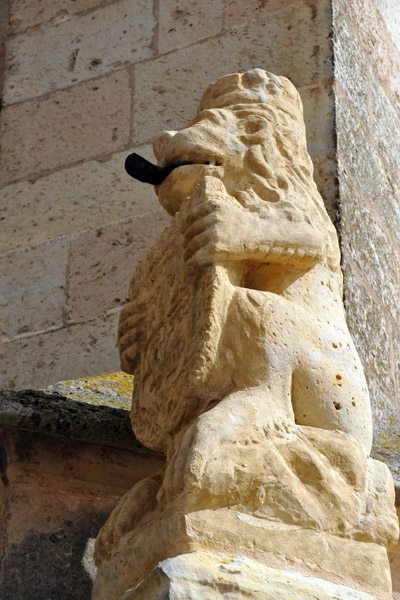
[0,146,159,253]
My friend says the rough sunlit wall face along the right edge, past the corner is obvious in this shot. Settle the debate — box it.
[333,0,400,436]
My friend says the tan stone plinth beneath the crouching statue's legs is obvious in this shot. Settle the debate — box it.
[93,508,392,600]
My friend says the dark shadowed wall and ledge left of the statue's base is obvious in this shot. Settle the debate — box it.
[0,398,164,600]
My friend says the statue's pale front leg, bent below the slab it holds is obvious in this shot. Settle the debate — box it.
[159,386,294,507]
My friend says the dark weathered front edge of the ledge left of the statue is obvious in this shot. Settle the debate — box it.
[0,390,157,455]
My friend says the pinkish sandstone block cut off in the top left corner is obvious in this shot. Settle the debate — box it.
[10,0,111,33]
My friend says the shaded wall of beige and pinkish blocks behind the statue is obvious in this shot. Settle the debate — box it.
[0,0,336,389]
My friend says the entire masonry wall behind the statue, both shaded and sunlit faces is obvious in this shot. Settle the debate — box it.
[0,0,400,432]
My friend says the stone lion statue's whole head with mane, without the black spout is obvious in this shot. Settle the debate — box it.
[153,69,339,269]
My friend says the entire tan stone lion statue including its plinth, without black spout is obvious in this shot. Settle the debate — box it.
[93,69,398,600]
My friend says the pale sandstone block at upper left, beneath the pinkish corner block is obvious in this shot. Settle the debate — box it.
[4,0,155,104]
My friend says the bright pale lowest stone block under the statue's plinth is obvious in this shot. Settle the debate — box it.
[119,551,377,600]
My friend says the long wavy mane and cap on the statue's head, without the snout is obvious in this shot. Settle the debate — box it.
[195,69,340,270]
